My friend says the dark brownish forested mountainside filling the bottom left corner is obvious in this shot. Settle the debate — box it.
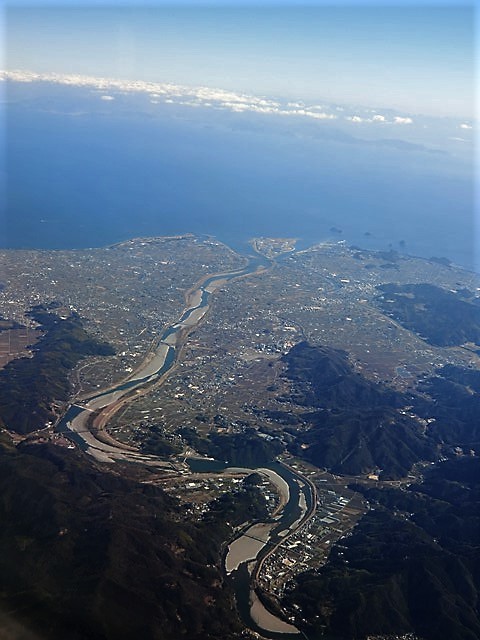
[0,438,265,640]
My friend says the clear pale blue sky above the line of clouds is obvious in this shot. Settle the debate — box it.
[4,0,475,119]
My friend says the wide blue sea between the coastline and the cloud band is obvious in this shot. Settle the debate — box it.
[0,85,476,269]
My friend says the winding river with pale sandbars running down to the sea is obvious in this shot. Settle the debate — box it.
[56,255,315,640]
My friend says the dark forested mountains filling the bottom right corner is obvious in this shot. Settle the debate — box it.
[284,457,480,640]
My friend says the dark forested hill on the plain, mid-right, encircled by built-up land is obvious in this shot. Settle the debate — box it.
[274,342,436,478]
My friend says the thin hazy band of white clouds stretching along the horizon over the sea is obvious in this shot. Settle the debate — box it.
[0,70,476,163]
